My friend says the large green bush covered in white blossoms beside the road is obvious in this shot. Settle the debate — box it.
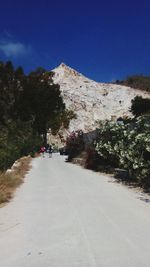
[95,116,150,191]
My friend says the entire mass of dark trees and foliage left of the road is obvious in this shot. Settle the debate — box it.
[0,61,74,170]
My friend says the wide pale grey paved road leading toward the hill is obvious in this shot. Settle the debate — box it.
[0,155,150,267]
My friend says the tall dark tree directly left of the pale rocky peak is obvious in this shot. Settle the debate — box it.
[19,68,66,143]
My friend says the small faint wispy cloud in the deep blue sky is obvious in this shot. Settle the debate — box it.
[0,41,31,57]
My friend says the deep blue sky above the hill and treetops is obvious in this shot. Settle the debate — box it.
[0,0,150,82]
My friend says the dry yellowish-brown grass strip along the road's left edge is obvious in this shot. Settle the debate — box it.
[0,157,31,204]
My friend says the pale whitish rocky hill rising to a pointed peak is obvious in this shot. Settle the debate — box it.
[52,63,150,132]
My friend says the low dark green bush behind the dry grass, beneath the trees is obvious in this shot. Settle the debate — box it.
[0,121,42,170]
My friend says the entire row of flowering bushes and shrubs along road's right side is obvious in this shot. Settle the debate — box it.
[66,97,150,192]
